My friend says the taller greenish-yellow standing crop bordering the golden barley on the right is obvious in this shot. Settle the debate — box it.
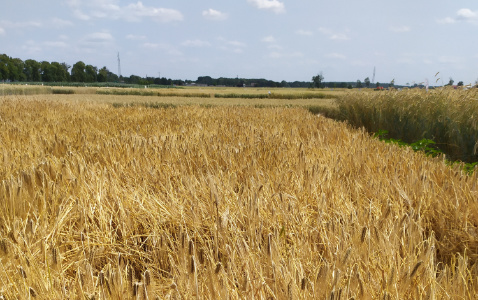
[337,89,478,162]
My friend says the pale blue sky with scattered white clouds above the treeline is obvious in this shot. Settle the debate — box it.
[0,0,478,85]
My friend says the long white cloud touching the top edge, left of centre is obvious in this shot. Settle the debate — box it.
[68,0,183,22]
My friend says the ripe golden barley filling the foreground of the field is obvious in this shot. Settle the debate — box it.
[0,95,478,299]
